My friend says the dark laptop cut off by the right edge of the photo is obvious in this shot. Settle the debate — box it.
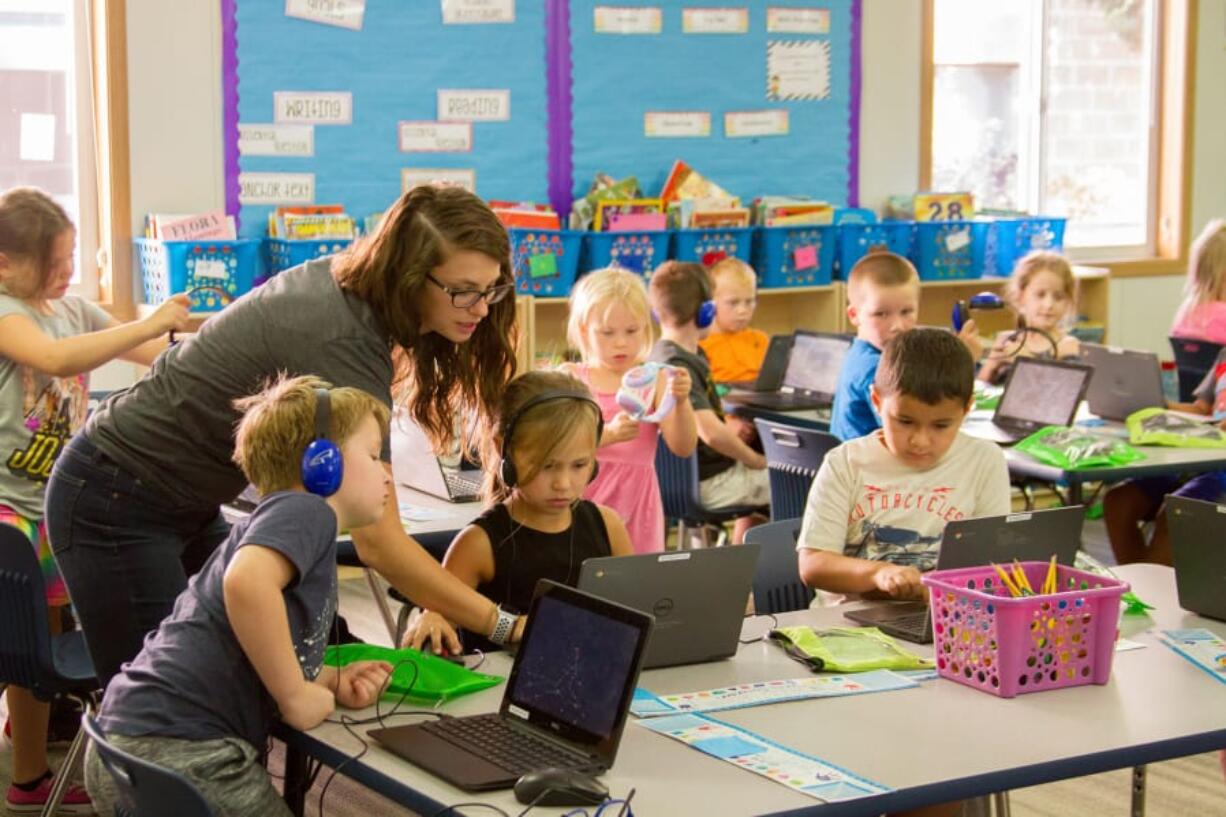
[1166,497,1226,621]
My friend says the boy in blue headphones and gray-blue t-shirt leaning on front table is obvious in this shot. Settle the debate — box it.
[86,377,391,816]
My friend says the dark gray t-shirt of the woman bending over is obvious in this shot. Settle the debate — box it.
[86,259,392,507]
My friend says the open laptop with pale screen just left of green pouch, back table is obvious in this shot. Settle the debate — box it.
[962,357,1091,445]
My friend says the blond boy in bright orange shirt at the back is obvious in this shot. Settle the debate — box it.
[699,258,770,383]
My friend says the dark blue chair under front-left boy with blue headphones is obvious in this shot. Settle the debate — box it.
[81,715,213,817]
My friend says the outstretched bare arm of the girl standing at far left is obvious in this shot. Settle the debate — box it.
[0,294,189,378]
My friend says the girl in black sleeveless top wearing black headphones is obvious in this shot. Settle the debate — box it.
[405,372,634,651]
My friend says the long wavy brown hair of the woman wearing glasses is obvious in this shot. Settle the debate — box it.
[332,186,517,450]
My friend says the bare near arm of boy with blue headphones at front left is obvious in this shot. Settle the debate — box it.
[222,545,336,729]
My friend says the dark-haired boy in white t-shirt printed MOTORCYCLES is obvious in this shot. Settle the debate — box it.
[797,329,1010,601]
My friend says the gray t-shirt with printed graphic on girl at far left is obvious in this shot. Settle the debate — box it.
[0,294,110,519]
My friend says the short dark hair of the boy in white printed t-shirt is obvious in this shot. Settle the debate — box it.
[873,328,975,406]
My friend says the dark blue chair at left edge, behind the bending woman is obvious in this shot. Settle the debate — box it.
[0,525,98,815]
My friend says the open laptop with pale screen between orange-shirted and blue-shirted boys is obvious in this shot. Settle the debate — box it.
[726,330,852,411]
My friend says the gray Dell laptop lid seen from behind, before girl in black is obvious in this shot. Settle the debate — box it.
[577,545,761,670]
